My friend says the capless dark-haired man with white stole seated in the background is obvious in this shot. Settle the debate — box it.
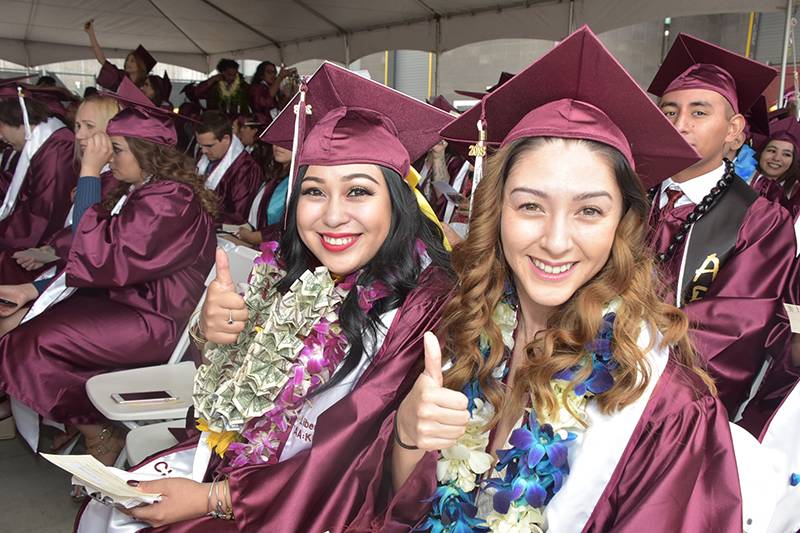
[195,111,264,225]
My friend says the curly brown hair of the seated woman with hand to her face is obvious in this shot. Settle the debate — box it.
[103,137,219,217]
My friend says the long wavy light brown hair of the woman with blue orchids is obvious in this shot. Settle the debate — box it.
[440,137,715,426]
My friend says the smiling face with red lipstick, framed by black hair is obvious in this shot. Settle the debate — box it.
[297,164,392,276]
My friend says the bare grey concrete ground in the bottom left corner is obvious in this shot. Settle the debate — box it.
[0,436,86,533]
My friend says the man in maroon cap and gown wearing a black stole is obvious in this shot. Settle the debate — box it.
[648,34,795,417]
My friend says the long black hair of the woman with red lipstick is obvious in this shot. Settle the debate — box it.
[278,167,452,394]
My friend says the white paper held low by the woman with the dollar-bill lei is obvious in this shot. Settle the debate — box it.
[40,453,161,509]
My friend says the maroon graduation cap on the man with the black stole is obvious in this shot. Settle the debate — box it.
[647,33,777,113]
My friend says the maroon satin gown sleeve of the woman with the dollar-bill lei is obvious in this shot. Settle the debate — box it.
[133,268,452,533]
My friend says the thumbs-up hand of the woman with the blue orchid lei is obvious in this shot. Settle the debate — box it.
[397,332,469,451]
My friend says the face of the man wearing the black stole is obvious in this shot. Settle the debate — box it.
[660,89,745,181]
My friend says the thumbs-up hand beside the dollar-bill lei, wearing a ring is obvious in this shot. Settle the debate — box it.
[200,248,248,344]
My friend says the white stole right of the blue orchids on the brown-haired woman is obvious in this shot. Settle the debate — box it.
[544,328,669,533]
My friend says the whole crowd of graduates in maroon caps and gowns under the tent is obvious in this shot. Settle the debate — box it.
[0,16,800,532]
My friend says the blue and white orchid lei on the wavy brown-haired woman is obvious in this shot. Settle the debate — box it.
[415,298,617,533]
